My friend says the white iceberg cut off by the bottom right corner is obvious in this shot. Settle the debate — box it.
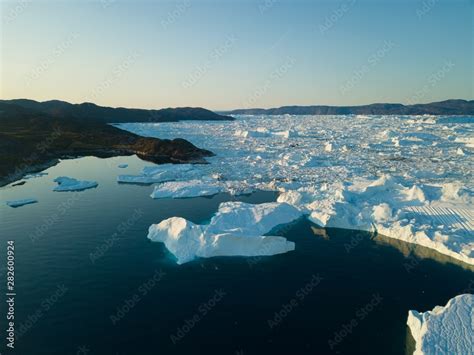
[407,294,474,355]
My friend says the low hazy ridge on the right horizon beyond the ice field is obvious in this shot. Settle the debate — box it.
[224,100,474,115]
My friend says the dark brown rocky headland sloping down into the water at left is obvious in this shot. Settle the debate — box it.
[0,102,213,186]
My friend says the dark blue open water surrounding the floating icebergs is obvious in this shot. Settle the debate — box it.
[0,157,474,355]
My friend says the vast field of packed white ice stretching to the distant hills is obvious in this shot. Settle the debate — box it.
[118,115,474,265]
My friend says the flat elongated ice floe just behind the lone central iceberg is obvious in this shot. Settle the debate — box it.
[150,180,224,199]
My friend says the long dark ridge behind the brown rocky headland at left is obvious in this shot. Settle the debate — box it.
[0,99,233,123]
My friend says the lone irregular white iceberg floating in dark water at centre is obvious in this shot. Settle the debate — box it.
[148,202,301,264]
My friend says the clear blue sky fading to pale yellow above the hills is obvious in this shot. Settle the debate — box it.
[0,0,474,110]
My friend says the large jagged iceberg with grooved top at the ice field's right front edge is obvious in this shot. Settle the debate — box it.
[308,175,474,264]
